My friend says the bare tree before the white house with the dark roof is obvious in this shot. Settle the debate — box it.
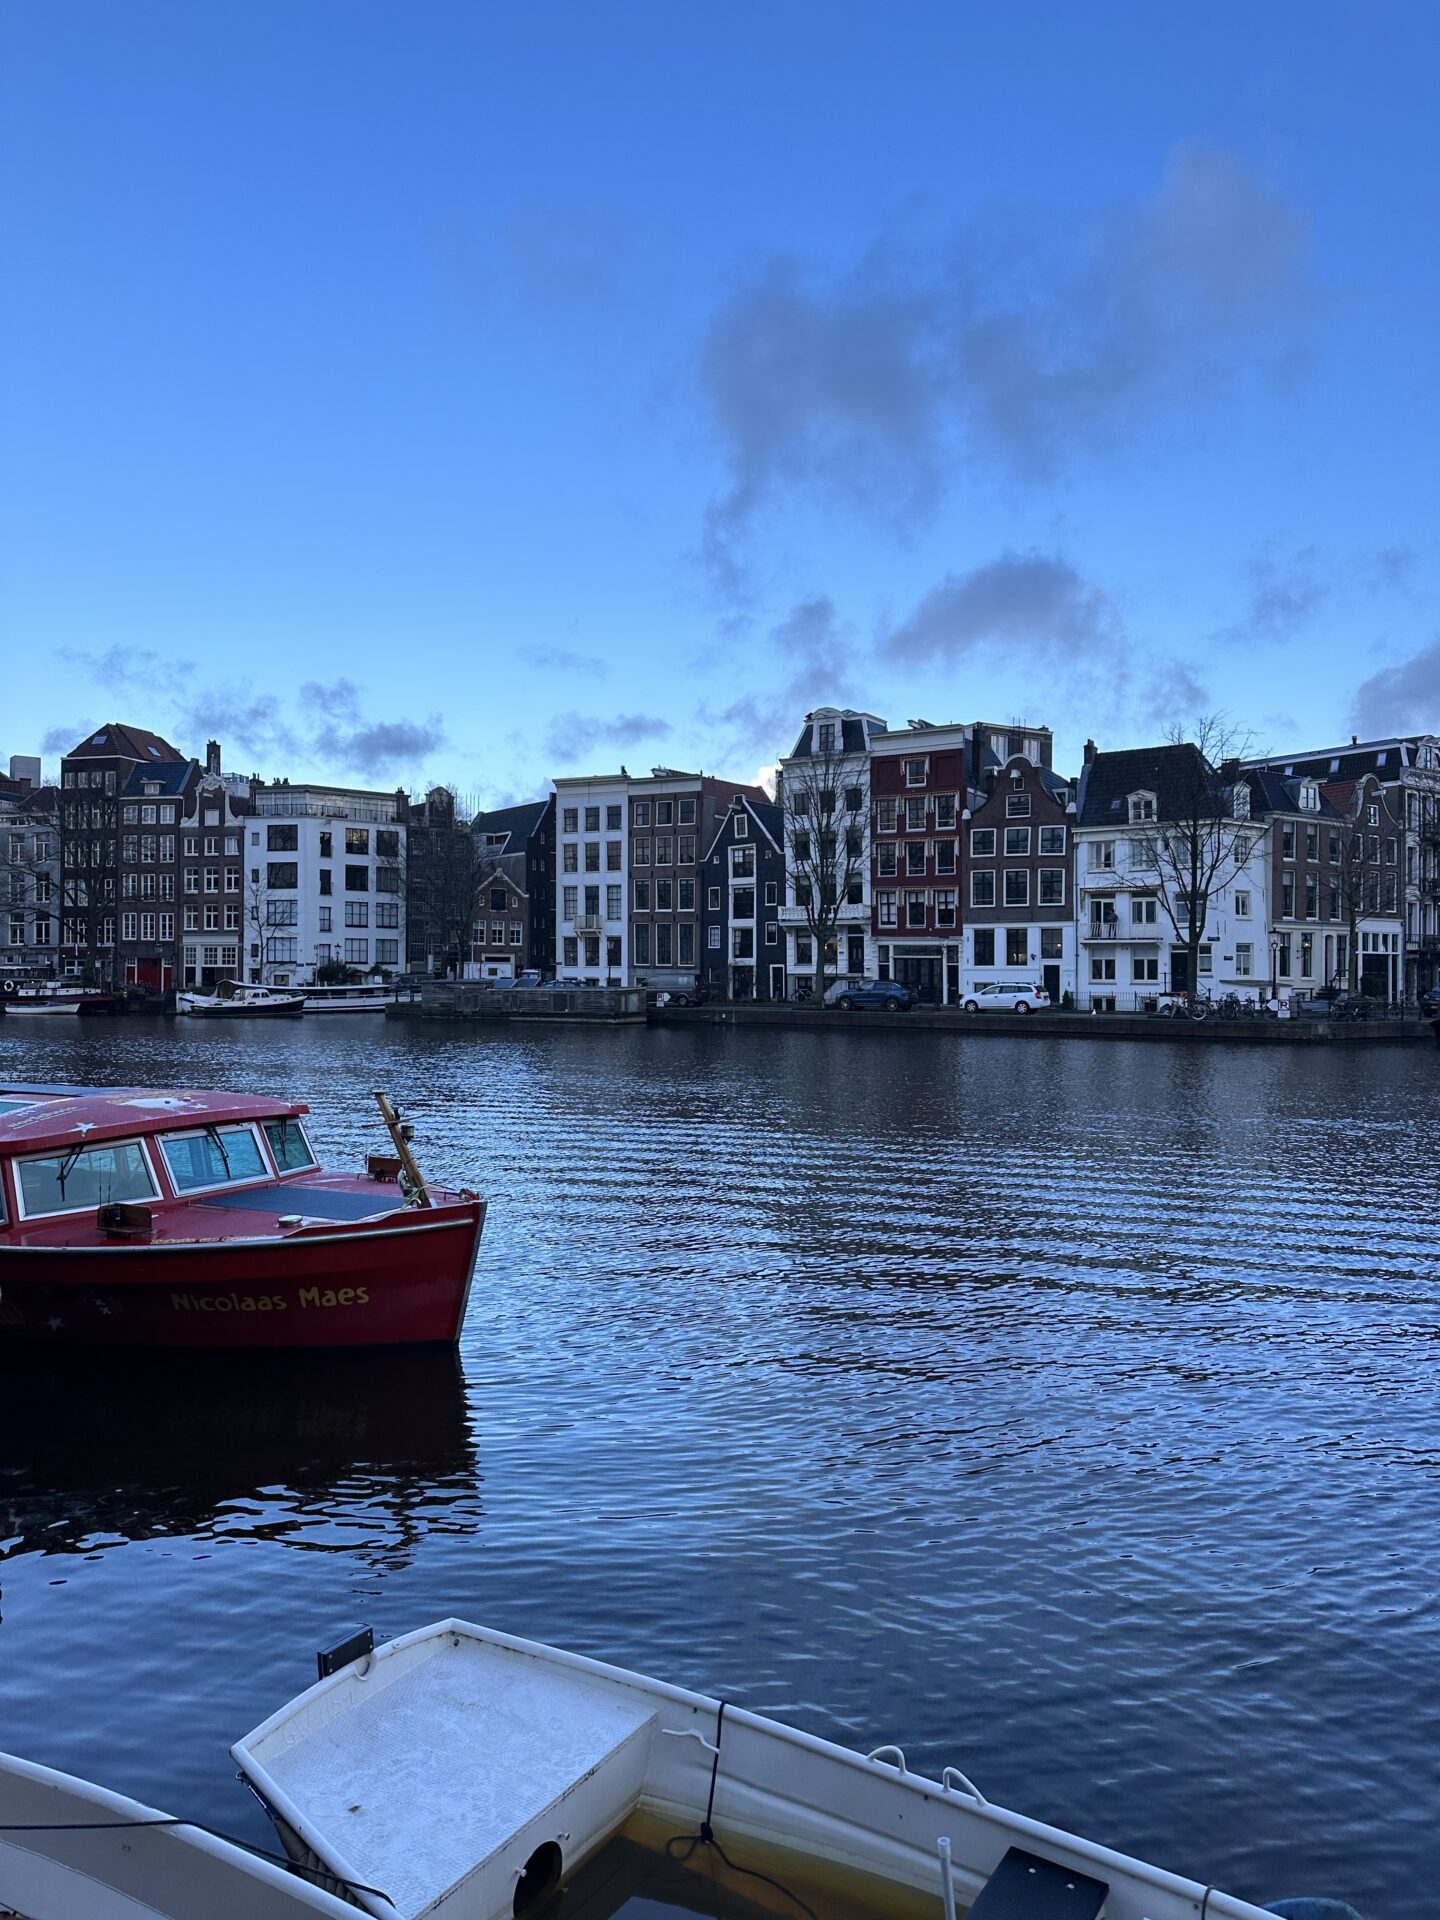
[1152,714,1258,993]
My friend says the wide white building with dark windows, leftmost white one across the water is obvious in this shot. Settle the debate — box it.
[242,780,405,987]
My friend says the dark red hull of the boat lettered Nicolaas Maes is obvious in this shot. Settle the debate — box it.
[0,1200,486,1350]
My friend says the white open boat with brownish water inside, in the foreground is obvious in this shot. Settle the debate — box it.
[232,1620,1328,1920]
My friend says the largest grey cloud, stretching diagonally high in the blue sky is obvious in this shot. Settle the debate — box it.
[697,144,1311,605]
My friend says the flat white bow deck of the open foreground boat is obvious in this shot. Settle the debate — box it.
[255,1644,653,1920]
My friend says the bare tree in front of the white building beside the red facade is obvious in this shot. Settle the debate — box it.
[781,726,868,998]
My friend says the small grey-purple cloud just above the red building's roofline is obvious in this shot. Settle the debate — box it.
[883,551,1121,664]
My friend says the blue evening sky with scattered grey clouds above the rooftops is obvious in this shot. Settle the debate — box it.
[0,0,1440,804]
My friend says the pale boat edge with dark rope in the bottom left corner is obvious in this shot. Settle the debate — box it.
[0,1753,355,1920]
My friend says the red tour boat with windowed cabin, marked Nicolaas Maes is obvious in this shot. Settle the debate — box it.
[0,1087,486,1348]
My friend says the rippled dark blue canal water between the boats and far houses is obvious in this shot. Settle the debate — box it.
[0,1016,1440,1920]
